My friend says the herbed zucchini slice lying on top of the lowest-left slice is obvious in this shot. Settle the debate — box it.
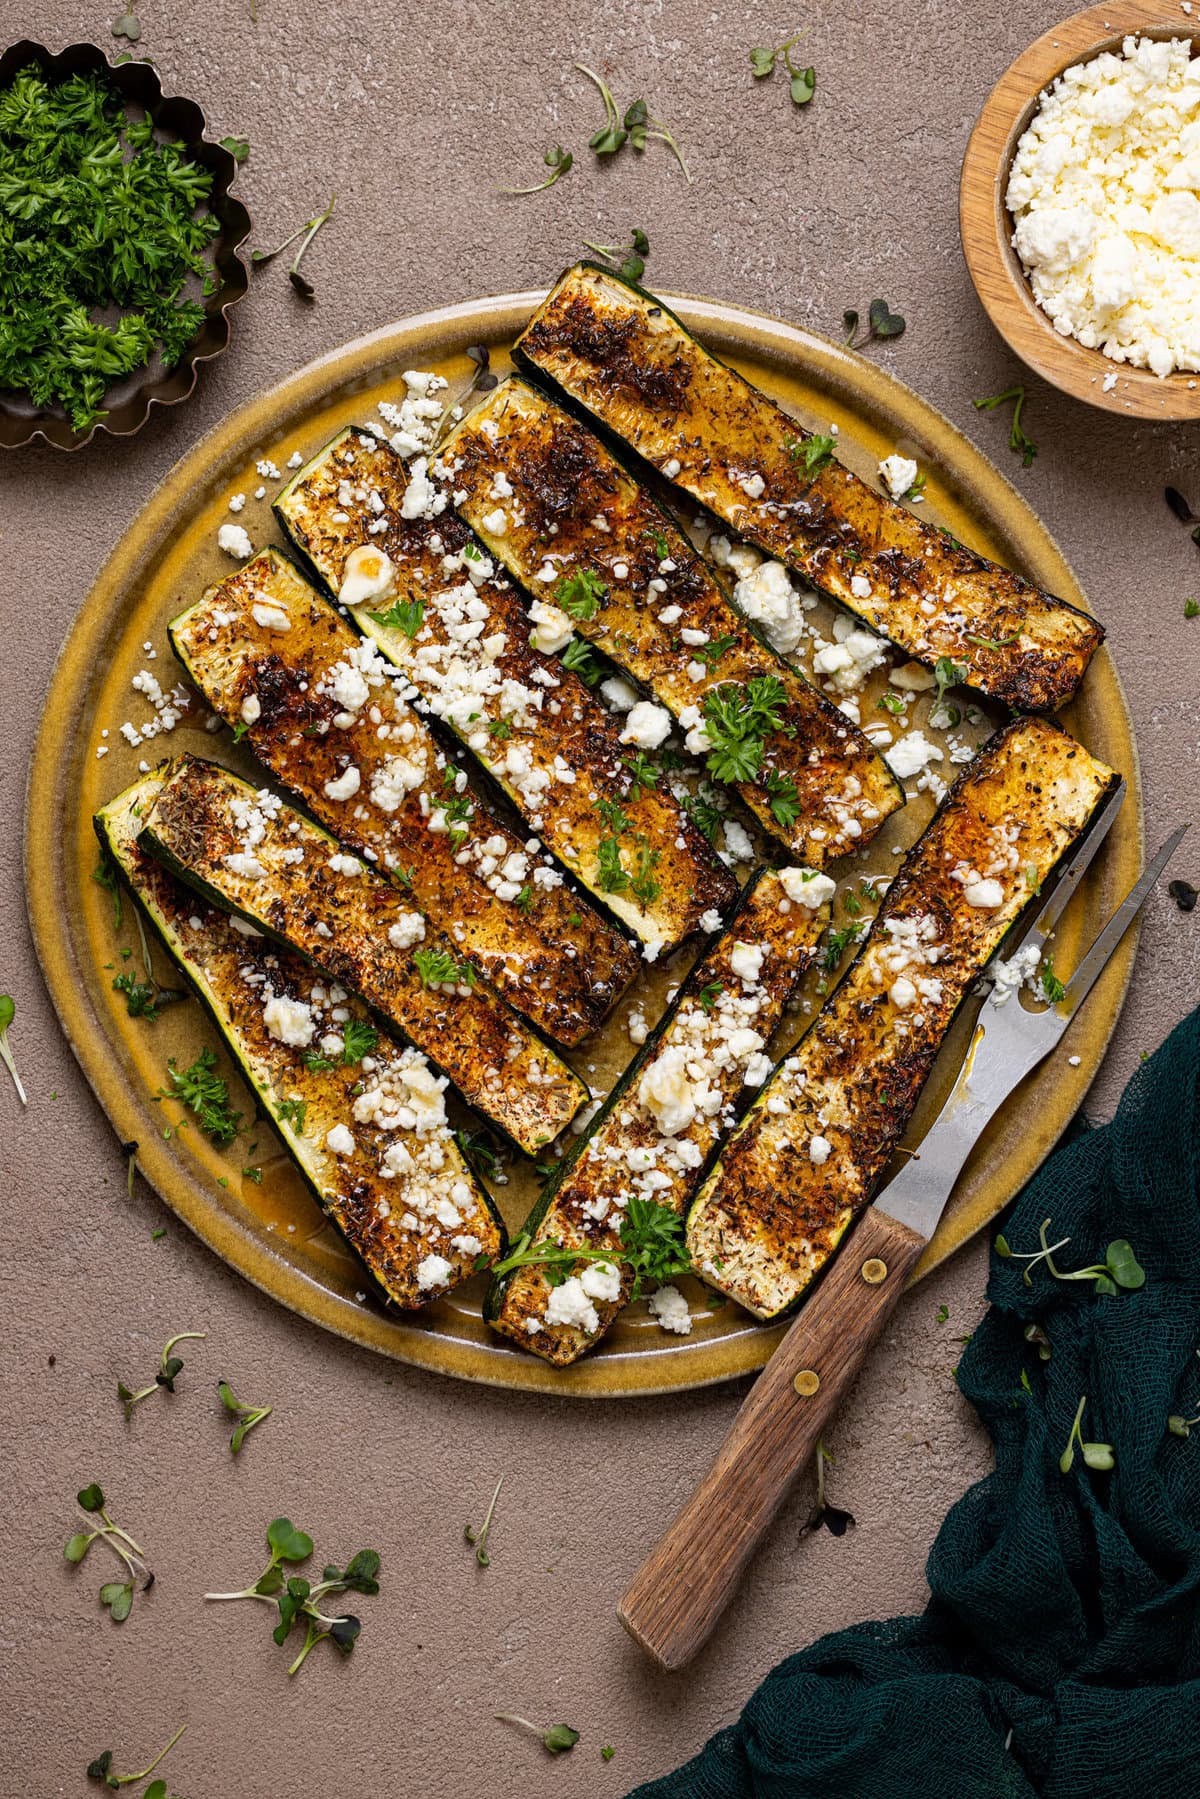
[139,756,588,1155]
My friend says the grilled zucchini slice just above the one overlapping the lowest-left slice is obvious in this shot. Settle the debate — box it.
[169,550,637,1043]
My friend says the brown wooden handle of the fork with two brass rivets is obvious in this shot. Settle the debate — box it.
[617,1207,925,1668]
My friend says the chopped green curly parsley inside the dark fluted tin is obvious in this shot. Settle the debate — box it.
[0,67,221,432]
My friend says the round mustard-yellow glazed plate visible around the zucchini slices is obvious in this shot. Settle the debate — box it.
[25,293,1141,1398]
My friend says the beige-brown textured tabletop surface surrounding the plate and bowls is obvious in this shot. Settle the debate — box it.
[0,0,1200,1799]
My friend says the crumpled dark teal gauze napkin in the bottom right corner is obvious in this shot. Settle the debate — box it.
[631,1013,1200,1799]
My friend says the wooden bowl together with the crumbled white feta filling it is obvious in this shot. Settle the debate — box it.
[959,0,1200,419]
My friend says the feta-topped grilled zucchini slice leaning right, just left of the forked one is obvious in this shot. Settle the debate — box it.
[484,869,831,1367]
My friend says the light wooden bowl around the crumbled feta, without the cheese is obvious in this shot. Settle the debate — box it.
[959,0,1200,419]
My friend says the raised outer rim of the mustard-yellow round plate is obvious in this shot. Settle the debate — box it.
[22,288,1142,1398]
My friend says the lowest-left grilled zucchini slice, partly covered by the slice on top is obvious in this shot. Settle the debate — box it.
[95,774,506,1306]
